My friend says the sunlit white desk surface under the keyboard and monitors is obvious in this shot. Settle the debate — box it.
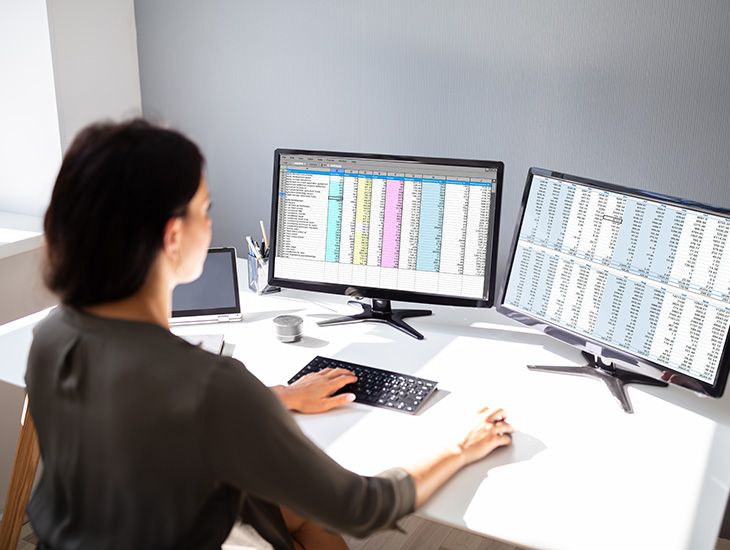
[5,285,730,550]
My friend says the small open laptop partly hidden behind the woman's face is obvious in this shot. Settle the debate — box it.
[169,247,242,325]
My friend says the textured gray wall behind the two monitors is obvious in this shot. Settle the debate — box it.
[135,0,730,284]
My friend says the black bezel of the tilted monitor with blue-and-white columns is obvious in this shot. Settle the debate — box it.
[496,167,730,397]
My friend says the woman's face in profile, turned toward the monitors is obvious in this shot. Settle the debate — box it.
[177,177,212,283]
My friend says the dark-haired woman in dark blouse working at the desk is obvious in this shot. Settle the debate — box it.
[26,120,512,550]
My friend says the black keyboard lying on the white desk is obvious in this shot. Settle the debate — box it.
[289,355,437,414]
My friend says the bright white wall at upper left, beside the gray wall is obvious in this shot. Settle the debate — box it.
[0,0,142,222]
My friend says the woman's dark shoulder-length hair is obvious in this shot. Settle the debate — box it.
[44,119,204,307]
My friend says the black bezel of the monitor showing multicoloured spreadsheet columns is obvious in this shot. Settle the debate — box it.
[269,148,504,308]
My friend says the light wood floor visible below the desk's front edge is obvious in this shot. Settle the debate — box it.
[4,516,730,550]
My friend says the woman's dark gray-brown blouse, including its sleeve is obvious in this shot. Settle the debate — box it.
[26,307,415,550]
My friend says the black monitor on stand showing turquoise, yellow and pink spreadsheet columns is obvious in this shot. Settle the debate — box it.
[269,149,504,339]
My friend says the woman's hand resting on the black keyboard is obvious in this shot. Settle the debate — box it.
[271,369,357,414]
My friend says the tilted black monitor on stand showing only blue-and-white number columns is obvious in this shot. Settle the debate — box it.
[497,168,730,408]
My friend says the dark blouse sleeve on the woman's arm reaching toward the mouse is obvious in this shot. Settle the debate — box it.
[201,360,416,537]
